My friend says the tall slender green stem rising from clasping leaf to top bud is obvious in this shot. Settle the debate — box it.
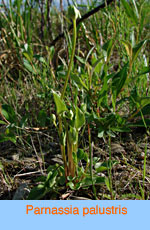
[61,19,77,99]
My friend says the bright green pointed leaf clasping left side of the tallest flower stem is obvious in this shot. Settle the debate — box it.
[53,91,67,114]
